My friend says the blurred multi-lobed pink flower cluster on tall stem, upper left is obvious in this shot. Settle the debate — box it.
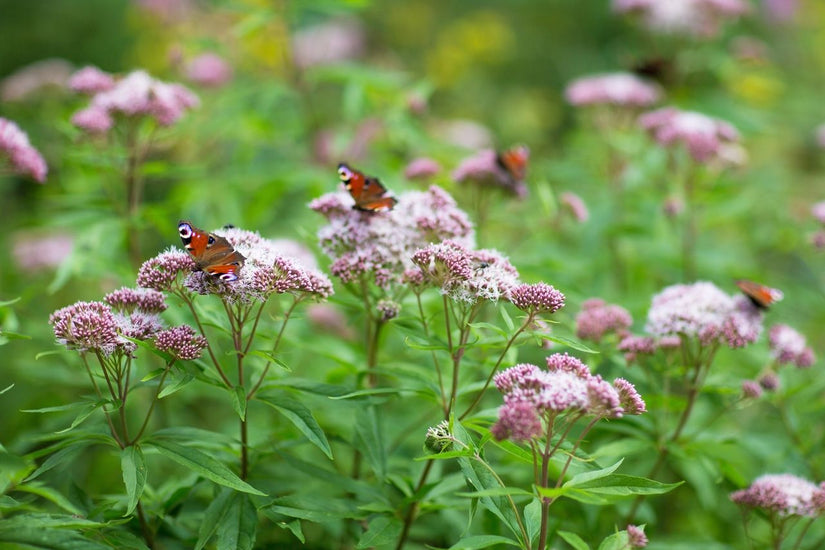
[70,67,199,134]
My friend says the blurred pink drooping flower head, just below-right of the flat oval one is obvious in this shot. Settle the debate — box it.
[639,107,739,163]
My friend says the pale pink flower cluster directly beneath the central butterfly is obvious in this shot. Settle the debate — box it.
[309,186,475,288]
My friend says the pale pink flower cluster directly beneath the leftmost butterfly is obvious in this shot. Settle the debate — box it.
[184,227,333,303]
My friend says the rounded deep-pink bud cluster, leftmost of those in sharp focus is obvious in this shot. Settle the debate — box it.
[49,302,124,355]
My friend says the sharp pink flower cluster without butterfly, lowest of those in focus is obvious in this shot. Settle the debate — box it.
[491,354,646,441]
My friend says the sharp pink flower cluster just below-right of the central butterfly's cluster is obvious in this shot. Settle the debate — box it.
[407,240,520,304]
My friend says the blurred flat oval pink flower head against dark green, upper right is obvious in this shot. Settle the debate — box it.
[564,73,661,107]
